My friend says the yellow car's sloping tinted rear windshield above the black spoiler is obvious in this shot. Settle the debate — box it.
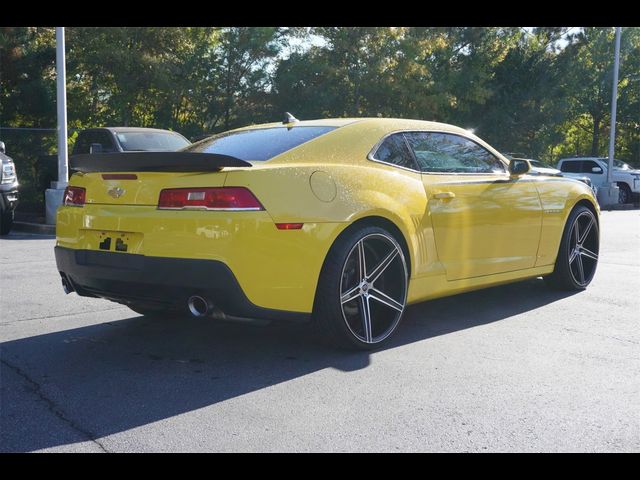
[184,127,336,161]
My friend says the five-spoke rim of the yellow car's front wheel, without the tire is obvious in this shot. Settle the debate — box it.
[567,211,599,287]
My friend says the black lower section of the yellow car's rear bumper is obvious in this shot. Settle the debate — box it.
[55,246,310,322]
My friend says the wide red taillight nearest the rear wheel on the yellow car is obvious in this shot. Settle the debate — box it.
[158,187,264,211]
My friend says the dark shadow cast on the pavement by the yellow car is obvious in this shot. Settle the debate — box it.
[0,279,571,452]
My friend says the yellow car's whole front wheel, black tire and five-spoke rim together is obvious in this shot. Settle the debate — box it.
[544,205,600,291]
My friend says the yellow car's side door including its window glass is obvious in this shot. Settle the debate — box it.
[405,132,542,280]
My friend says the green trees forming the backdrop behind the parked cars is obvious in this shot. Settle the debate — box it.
[0,27,640,212]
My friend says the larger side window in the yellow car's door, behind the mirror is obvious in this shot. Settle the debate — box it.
[405,132,506,173]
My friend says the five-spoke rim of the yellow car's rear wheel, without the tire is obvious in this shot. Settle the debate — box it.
[340,233,407,344]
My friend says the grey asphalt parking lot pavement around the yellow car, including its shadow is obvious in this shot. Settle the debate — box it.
[0,210,640,452]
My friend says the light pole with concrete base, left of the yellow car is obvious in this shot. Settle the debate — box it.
[45,27,69,225]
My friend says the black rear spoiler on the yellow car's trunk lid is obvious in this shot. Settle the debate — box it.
[69,152,251,173]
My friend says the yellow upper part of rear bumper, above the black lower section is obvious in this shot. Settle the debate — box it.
[56,204,347,313]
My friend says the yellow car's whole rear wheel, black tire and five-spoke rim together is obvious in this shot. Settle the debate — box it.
[313,226,409,350]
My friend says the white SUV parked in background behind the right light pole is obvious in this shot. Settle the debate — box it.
[558,157,640,203]
